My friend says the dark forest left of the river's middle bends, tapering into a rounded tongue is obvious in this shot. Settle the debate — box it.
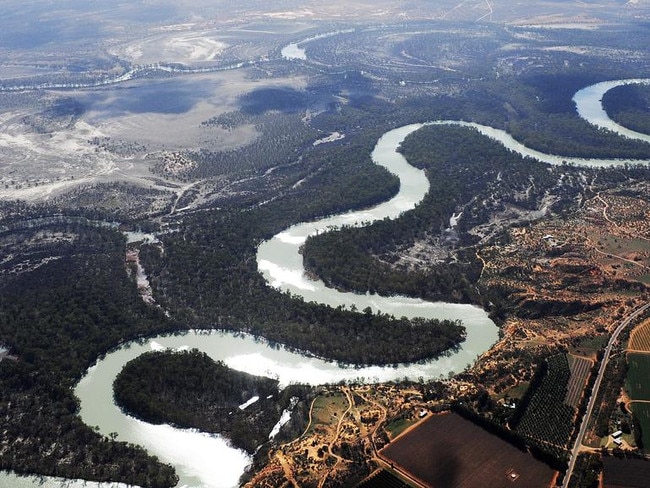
[140,127,464,364]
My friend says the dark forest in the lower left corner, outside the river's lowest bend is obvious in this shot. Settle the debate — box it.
[0,224,177,487]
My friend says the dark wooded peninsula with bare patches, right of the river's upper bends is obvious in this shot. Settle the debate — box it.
[303,126,557,302]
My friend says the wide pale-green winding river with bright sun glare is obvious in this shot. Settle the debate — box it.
[0,80,649,488]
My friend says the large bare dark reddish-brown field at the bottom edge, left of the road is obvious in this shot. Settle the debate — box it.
[380,413,555,488]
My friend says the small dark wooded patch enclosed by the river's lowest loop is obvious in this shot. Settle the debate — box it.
[113,350,311,453]
